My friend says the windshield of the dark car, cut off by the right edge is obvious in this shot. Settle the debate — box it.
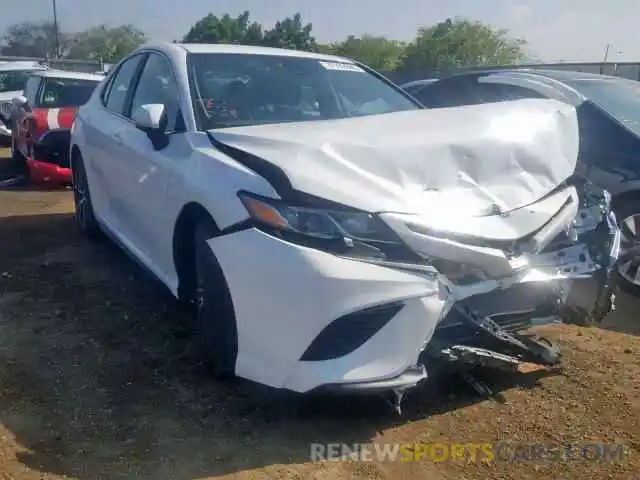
[567,79,640,135]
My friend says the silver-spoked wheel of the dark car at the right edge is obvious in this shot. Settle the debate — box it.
[615,198,640,295]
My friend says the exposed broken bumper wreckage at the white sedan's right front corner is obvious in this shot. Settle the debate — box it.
[380,181,620,411]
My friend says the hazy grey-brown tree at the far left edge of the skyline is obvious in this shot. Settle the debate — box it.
[0,22,69,58]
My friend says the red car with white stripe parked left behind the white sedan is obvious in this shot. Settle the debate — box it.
[11,70,104,185]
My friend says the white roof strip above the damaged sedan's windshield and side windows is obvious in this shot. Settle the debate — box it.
[143,43,353,63]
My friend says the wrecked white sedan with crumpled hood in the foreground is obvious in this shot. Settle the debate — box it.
[71,44,619,406]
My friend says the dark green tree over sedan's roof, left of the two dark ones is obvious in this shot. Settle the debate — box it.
[182,11,264,45]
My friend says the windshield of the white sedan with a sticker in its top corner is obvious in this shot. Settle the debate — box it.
[188,53,419,130]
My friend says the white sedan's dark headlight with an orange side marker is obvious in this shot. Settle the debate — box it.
[238,192,421,261]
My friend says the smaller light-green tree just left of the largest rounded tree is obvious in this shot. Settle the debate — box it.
[328,35,405,72]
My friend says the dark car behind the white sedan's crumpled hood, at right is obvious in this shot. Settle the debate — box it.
[403,69,640,294]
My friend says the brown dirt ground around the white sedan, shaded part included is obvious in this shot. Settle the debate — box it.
[0,148,640,480]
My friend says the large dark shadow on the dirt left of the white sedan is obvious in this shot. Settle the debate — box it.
[0,214,560,480]
